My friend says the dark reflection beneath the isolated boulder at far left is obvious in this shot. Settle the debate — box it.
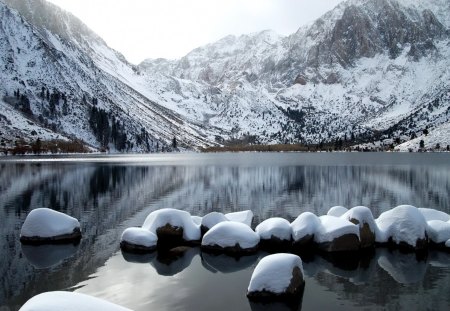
[22,243,78,269]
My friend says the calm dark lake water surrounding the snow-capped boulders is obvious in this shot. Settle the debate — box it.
[0,153,450,311]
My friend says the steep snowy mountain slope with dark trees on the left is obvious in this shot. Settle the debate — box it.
[0,0,220,151]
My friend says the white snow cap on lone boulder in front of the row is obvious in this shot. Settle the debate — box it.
[248,253,303,294]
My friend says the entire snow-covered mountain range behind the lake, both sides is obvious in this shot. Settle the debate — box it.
[0,0,450,151]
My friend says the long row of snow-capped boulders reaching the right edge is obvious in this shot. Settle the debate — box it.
[121,205,450,255]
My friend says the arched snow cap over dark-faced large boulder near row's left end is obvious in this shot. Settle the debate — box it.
[142,208,201,241]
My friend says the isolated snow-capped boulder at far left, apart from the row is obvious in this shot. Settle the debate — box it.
[20,208,81,244]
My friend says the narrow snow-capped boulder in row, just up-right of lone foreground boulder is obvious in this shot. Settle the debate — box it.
[291,212,320,250]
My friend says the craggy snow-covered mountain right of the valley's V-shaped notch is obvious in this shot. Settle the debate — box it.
[140,0,450,147]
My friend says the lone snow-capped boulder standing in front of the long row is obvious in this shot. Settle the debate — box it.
[247,253,305,300]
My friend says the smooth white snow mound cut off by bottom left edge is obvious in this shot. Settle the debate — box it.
[19,292,131,311]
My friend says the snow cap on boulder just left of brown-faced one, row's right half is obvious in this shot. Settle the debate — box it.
[314,215,359,243]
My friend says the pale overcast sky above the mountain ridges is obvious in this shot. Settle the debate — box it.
[49,0,342,64]
